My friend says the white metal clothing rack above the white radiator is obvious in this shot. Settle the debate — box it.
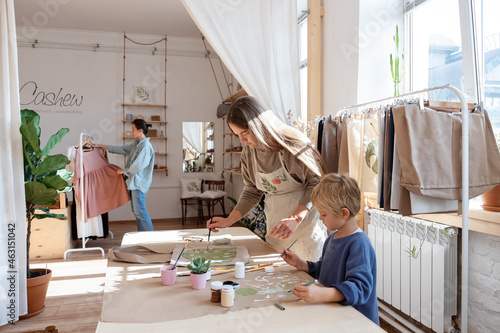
[337,84,469,333]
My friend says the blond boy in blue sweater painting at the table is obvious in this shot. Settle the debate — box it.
[283,173,379,325]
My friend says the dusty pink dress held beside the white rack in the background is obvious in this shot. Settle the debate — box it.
[73,148,130,221]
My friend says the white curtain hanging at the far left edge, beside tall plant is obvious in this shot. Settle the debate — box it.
[0,0,27,325]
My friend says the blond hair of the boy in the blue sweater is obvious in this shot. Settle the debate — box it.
[311,173,361,217]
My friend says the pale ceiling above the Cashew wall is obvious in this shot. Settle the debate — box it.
[14,0,307,38]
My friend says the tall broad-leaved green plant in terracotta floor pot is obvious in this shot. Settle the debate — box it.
[19,109,71,318]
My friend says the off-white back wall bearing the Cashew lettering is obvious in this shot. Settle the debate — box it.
[19,29,232,221]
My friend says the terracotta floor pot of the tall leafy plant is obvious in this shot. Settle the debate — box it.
[19,268,52,319]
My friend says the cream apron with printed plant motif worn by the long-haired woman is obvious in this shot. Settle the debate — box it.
[252,152,327,261]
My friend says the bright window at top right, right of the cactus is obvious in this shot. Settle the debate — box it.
[405,0,500,137]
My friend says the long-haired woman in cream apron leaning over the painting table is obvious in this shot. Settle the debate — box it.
[207,96,327,261]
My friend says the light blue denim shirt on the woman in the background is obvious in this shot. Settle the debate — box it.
[108,138,155,193]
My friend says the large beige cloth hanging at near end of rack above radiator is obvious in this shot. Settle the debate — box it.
[393,105,500,200]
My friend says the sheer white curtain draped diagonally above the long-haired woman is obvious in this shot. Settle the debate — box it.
[182,0,300,123]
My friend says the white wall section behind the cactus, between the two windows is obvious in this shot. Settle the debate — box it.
[322,0,404,115]
